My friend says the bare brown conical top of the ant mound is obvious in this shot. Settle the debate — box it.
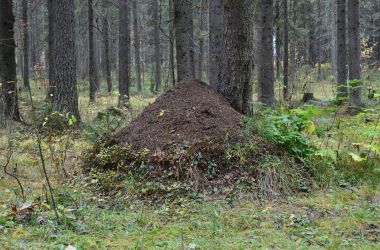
[118,80,243,152]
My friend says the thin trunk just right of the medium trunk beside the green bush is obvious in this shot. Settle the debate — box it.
[282,0,289,100]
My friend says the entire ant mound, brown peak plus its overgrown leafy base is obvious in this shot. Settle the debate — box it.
[83,80,309,204]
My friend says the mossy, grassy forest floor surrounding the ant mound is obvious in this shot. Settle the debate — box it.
[0,67,380,249]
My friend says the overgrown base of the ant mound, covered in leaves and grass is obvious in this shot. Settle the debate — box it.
[84,134,311,205]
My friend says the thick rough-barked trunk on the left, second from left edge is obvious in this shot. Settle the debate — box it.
[48,0,80,120]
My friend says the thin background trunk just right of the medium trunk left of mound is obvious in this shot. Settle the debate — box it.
[132,0,142,93]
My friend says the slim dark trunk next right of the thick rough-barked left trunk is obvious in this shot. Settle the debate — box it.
[87,0,99,102]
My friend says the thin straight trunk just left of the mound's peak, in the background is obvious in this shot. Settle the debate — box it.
[152,0,161,92]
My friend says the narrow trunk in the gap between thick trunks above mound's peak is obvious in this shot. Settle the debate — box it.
[198,0,208,80]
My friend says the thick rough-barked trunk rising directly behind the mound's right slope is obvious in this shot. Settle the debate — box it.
[219,0,252,114]
